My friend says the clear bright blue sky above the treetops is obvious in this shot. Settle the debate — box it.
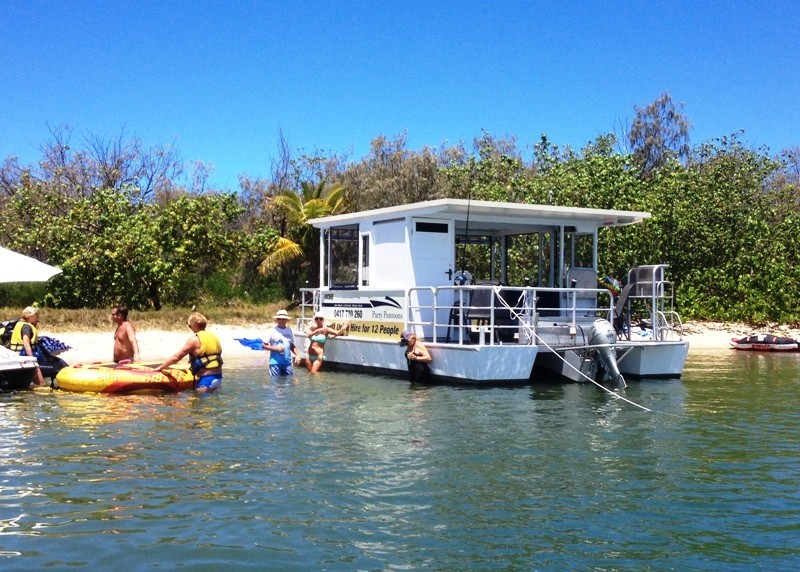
[0,0,800,189]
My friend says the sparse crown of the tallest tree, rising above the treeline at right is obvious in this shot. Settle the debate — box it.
[628,92,692,178]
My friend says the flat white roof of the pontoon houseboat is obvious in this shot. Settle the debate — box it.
[309,199,651,234]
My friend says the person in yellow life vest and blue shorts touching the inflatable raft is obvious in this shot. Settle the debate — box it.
[155,312,222,393]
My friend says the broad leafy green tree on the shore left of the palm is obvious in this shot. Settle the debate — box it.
[2,187,241,310]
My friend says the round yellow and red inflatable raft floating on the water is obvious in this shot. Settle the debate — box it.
[56,363,194,393]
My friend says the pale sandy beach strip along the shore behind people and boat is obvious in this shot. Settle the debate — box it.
[41,322,800,364]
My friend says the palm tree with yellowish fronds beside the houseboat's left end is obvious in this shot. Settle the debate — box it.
[258,180,345,296]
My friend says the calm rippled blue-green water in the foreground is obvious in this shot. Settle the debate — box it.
[0,351,800,571]
